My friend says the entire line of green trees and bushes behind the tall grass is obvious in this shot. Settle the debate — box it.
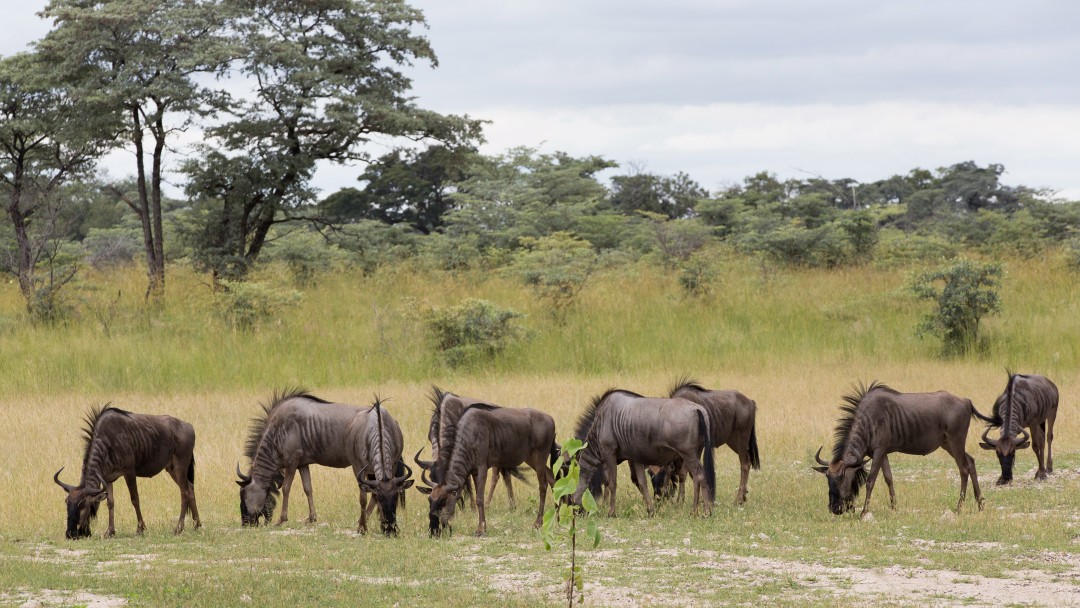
[0,0,1080,328]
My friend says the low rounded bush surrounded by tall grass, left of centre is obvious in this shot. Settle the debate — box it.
[424,298,525,367]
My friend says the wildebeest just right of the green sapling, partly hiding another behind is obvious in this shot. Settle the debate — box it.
[573,389,716,516]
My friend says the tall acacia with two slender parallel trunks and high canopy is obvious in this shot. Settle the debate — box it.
[38,0,225,298]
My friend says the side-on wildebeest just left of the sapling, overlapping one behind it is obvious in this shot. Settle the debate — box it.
[418,403,558,537]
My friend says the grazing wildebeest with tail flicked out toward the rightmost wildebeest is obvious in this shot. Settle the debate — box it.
[813,382,990,515]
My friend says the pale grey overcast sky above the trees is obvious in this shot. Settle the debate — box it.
[0,0,1080,200]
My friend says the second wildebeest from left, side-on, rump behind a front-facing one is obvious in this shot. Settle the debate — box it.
[237,389,361,526]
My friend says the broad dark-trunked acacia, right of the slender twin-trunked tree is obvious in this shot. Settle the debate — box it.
[184,0,481,273]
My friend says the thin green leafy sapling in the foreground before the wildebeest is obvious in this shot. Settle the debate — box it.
[540,437,600,606]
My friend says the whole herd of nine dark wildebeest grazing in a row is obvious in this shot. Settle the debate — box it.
[53,373,1058,539]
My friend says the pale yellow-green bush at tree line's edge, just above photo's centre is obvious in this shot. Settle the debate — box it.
[513,232,597,320]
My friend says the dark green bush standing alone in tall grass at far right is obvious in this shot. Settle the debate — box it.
[909,259,1004,355]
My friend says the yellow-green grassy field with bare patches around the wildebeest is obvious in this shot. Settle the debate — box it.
[0,254,1080,606]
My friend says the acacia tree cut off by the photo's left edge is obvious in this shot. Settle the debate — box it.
[0,54,114,317]
